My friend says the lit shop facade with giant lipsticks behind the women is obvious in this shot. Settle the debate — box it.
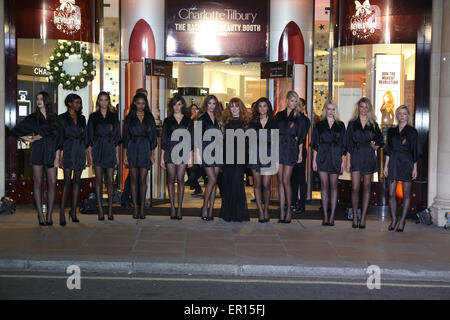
[4,0,450,226]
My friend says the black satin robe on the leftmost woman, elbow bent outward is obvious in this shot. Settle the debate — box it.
[11,111,62,168]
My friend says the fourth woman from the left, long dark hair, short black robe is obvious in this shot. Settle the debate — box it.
[123,93,158,219]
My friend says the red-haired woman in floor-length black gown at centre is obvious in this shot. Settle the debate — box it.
[220,98,250,222]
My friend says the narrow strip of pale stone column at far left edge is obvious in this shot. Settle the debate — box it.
[0,1,6,197]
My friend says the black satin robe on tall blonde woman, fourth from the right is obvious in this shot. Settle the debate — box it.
[275,109,306,166]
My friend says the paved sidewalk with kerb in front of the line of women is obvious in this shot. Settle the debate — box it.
[0,210,450,281]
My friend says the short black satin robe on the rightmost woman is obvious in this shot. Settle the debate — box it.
[384,125,420,182]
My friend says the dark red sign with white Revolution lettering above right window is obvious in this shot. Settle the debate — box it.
[335,0,429,46]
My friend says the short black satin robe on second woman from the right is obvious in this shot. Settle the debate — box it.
[347,118,384,175]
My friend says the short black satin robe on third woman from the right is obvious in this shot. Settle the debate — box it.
[311,119,346,174]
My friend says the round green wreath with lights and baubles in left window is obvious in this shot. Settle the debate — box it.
[47,42,95,91]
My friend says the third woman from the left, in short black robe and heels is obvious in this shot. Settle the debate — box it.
[87,92,120,221]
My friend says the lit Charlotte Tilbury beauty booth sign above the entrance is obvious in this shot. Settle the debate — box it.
[166,0,269,61]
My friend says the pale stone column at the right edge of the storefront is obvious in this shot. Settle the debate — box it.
[430,0,450,226]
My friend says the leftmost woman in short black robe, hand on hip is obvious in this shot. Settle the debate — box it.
[11,92,62,226]
